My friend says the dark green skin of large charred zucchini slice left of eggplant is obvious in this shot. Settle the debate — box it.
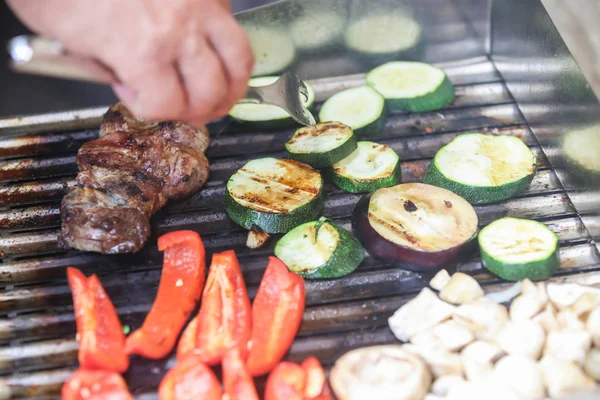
[223,189,324,234]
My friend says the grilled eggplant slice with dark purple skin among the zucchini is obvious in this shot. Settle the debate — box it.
[352,183,478,272]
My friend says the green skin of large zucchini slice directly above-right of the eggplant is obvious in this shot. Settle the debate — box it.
[423,158,535,204]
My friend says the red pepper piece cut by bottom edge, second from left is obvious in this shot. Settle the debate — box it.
[158,354,223,400]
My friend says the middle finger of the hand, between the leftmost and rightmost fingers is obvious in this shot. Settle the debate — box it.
[178,42,229,124]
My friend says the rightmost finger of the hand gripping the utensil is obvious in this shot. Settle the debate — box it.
[208,11,254,115]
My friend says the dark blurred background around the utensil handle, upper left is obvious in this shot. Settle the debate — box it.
[0,0,275,116]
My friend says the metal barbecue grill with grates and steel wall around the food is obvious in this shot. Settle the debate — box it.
[0,0,600,398]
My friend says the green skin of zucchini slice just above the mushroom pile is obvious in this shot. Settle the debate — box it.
[481,247,560,282]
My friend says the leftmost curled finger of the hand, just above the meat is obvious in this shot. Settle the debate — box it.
[115,65,187,120]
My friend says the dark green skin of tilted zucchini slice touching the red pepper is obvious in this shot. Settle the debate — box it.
[275,221,365,279]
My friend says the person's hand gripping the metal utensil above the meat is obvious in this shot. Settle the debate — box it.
[7,0,254,125]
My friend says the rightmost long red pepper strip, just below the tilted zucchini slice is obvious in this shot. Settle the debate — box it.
[246,257,305,376]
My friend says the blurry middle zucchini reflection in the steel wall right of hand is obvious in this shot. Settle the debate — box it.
[290,12,346,53]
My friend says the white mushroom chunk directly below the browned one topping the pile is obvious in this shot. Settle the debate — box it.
[453,297,508,340]
